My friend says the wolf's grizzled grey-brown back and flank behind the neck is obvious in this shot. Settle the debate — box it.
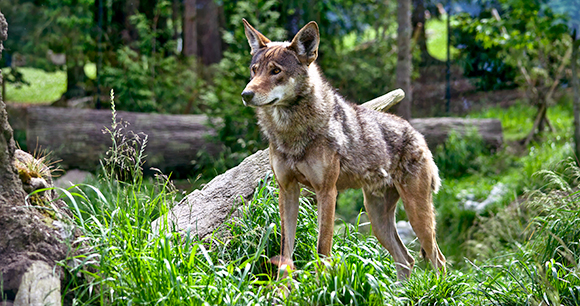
[329,97,440,192]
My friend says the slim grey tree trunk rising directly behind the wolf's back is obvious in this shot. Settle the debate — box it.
[395,0,413,120]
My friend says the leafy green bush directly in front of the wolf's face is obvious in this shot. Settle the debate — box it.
[202,1,286,164]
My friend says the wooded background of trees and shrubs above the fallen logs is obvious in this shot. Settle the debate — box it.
[0,0,578,158]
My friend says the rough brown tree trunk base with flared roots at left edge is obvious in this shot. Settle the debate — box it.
[0,13,66,305]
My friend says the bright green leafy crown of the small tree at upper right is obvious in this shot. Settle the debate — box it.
[462,0,571,103]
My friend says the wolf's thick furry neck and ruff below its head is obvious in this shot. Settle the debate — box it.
[257,64,336,157]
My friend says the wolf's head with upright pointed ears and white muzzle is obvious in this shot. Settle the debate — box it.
[242,19,320,107]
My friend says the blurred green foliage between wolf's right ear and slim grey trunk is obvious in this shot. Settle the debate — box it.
[317,2,397,103]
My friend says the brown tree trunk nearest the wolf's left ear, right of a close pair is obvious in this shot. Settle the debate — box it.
[197,0,222,66]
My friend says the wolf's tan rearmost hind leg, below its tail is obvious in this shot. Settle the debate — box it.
[397,169,446,273]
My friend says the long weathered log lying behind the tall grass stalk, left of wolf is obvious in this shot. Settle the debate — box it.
[26,107,219,173]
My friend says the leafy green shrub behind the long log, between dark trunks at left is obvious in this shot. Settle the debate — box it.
[102,1,204,113]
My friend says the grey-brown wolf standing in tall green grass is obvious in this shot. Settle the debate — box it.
[242,19,445,280]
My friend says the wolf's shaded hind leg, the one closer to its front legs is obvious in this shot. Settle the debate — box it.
[363,187,415,280]
